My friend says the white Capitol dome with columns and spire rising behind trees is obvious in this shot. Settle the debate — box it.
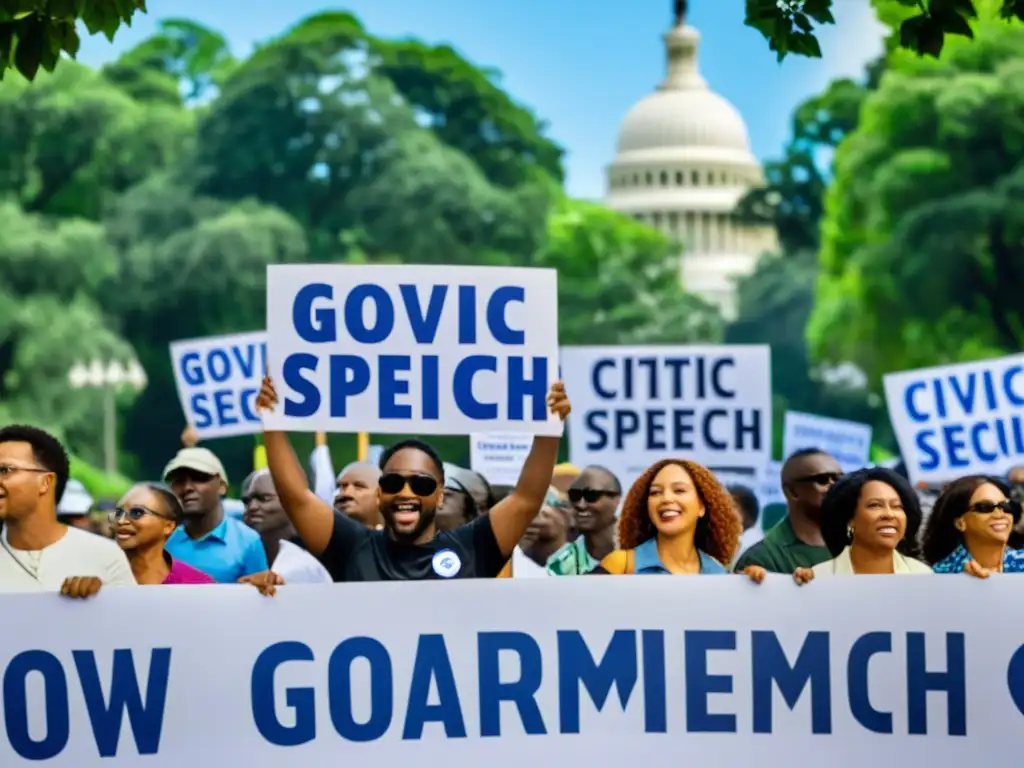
[605,2,776,317]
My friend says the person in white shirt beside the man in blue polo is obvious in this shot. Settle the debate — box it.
[242,469,333,584]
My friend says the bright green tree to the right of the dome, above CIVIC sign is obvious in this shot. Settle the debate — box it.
[808,13,1024,380]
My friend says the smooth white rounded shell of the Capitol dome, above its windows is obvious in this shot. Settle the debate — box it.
[616,90,751,154]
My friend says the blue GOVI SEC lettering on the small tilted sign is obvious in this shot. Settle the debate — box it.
[178,343,266,429]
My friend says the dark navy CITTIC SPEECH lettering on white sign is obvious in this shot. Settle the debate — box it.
[584,355,767,453]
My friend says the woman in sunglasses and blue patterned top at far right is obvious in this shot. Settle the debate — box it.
[923,475,1024,579]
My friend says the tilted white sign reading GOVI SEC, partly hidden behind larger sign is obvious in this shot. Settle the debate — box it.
[171,331,266,440]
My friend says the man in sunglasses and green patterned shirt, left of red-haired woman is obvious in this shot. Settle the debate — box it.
[548,467,623,575]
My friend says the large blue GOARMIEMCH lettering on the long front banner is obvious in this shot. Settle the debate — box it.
[245,629,966,746]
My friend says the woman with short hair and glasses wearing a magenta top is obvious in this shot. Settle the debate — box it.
[110,482,216,585]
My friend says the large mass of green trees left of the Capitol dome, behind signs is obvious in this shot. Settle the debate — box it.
[0,12,721,476]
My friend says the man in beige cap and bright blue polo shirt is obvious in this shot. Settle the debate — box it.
[164,447,267,584]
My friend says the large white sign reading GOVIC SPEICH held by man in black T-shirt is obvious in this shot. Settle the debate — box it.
[264,264,562,435]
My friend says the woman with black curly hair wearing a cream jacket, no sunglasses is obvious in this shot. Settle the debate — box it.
[794,467,932,584]
